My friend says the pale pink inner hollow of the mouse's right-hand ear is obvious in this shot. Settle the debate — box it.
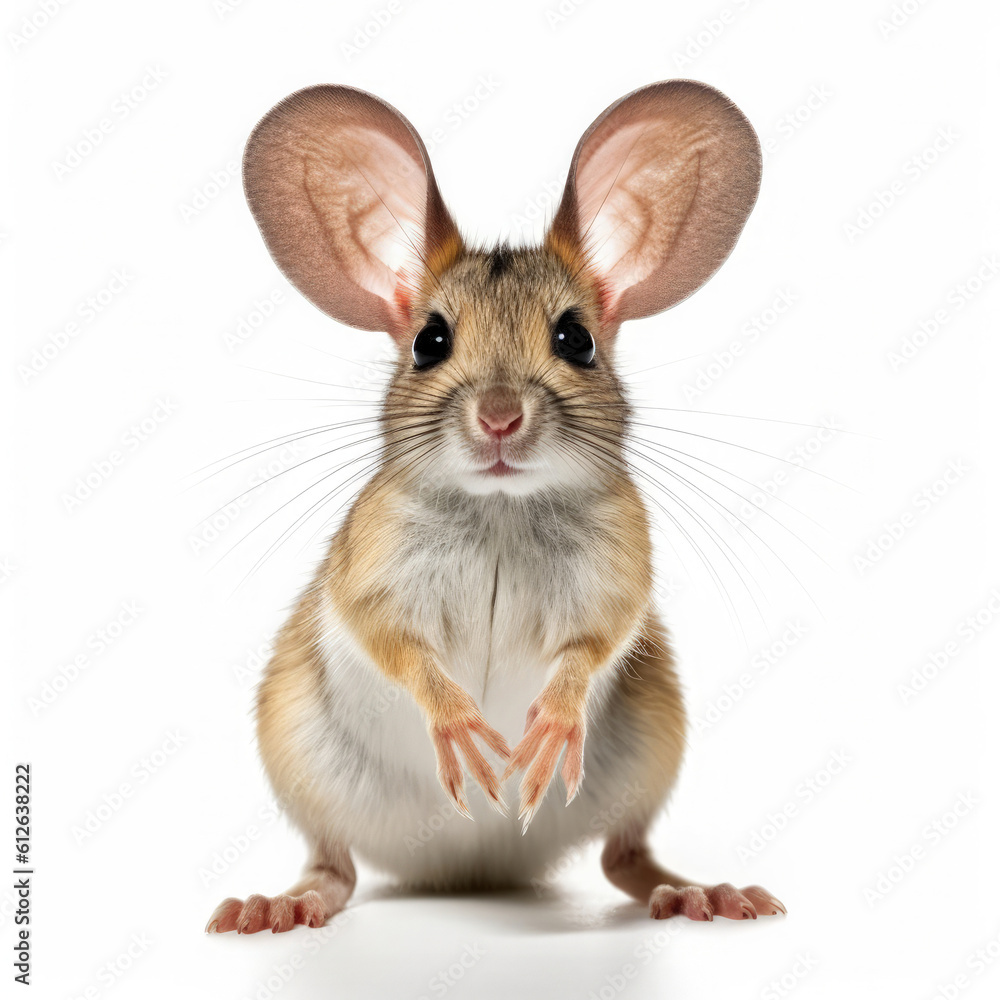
[576,119,698,312]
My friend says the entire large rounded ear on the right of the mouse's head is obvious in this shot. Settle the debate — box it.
[548,80,761,330]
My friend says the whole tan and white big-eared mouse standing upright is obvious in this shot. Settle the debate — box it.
[207,80,784,933]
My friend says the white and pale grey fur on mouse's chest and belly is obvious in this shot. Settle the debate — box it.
[299,488,649,887]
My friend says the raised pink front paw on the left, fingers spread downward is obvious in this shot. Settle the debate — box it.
[429,691,510,819]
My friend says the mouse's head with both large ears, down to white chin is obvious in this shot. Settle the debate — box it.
[244,80,761,495]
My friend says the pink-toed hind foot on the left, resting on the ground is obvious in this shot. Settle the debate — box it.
[205,849,357,934]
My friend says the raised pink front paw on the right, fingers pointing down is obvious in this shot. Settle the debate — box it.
[503,693,586,834]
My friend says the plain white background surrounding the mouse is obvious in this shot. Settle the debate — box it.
[0,0,1000,1000]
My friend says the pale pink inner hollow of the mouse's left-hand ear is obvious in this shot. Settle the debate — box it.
[306,129,427,308]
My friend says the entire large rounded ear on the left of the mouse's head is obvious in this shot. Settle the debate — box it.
[243,86,462,336]
